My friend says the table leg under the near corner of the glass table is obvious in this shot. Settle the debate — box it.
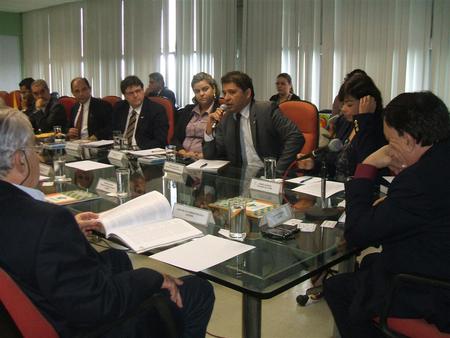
[242,294,261,338]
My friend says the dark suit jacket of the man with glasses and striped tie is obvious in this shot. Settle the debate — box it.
[113,97,169,149]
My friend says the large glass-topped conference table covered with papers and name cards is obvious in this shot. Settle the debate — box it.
[39,151,357,338]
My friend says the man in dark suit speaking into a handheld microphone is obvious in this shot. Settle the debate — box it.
[203,71,304,175]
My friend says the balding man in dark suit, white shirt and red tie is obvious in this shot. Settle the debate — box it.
[67,77,112,141]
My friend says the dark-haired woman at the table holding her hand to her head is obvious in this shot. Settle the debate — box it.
[298,72,386,182]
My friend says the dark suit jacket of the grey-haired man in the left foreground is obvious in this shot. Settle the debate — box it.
[0,180,163,337]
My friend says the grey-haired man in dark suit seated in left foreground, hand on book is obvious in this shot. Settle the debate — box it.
[0,111,214,338]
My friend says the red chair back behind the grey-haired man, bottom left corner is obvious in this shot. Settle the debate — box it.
[0,268,59,338]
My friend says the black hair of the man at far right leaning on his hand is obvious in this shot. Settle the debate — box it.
[384,91,450,146]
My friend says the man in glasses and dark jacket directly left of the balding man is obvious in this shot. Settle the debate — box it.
[30,80,68,133]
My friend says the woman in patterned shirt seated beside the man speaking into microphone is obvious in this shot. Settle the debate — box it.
[171,72,220,159]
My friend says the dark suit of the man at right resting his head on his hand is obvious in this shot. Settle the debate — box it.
[345,141,450,332]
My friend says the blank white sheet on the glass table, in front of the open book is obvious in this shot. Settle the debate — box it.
[150,235,255,272]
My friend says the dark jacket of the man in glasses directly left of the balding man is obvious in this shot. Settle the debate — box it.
[30,97,68,133]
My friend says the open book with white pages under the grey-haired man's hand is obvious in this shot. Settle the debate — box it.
[100,191,203,253]
